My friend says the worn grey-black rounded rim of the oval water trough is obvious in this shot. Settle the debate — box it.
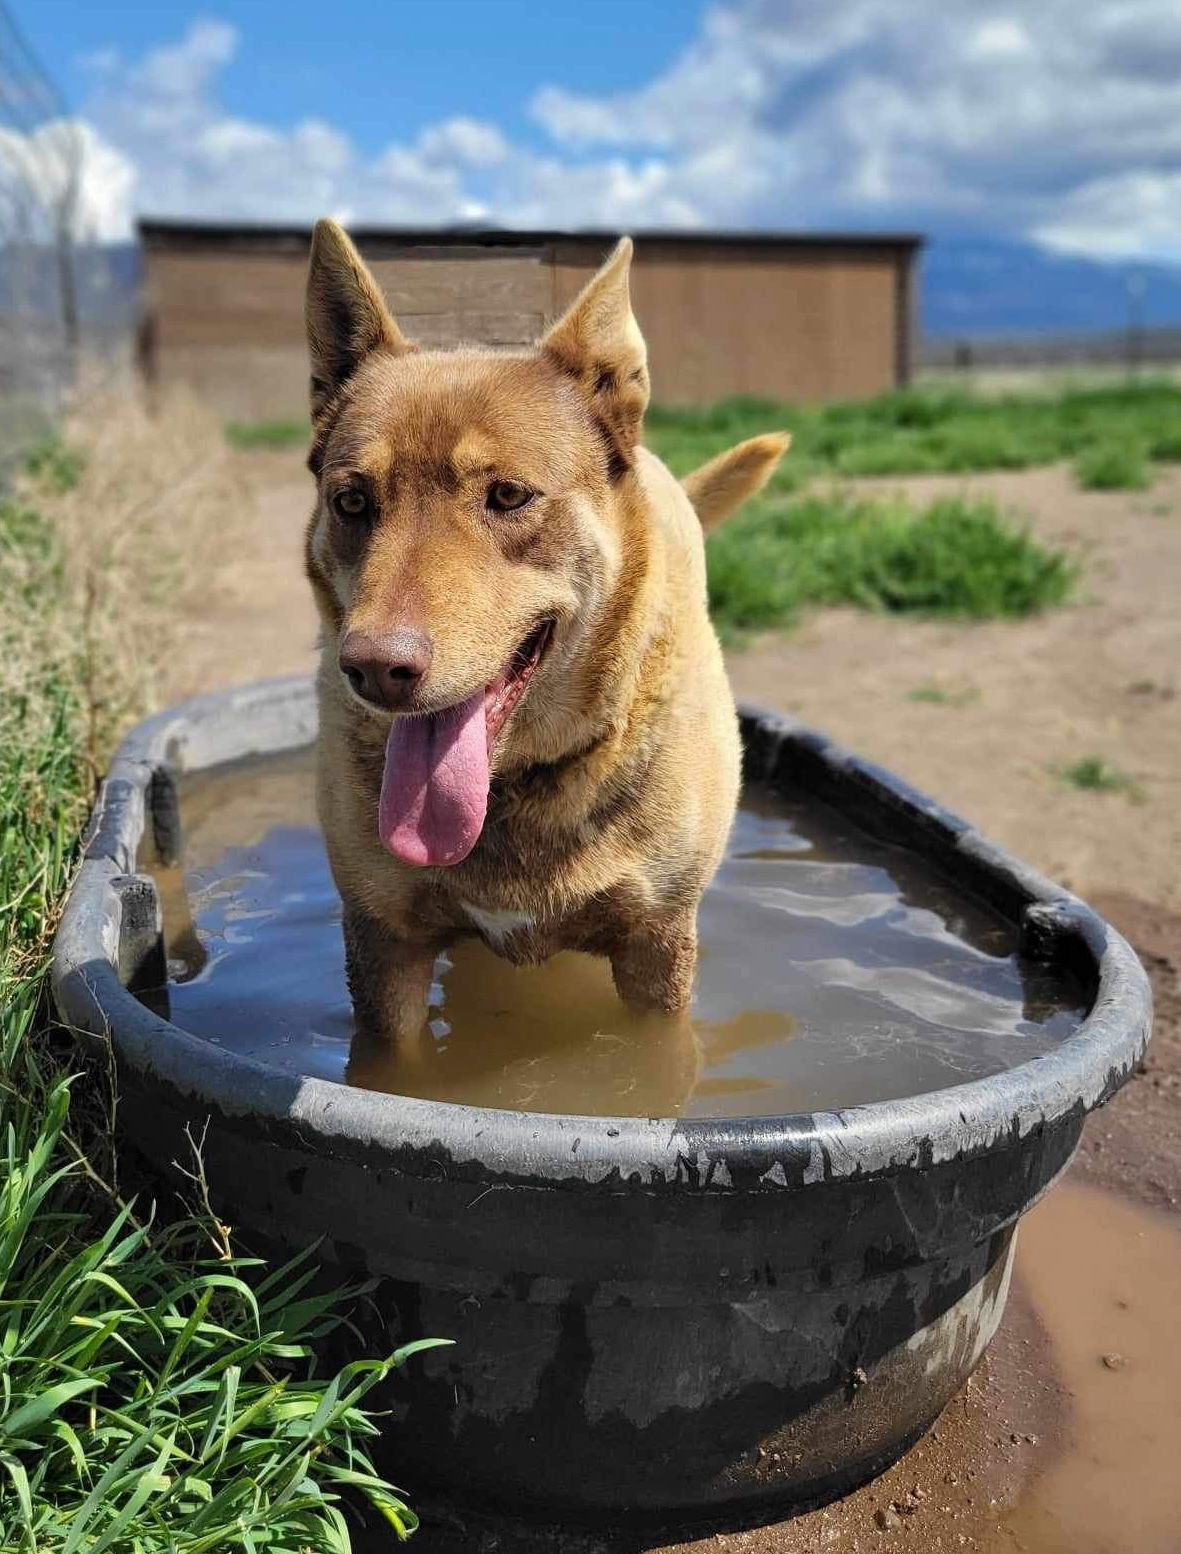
[53,674,1151,1193]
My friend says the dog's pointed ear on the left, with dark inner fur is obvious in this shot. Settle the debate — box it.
[305,221,413,416]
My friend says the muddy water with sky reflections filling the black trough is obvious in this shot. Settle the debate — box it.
[142,752,1085,1116]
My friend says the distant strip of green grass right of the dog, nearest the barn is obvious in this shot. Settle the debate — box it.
[646,381,1181,493]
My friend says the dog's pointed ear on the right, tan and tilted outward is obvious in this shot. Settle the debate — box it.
[541,238,648,466]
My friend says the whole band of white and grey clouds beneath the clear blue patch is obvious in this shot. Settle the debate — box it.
[9,0,1181,258]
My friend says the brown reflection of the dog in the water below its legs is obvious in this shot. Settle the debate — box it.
[348,940,793,1117]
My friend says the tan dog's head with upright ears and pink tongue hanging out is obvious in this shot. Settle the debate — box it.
[306,221,648,864]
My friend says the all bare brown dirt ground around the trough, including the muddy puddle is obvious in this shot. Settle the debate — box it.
[166,454,1181,1554]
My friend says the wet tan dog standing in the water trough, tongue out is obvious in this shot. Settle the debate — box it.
[306,221,788,1035]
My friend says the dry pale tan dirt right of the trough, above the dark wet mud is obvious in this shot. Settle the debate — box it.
[730,468,1181,911]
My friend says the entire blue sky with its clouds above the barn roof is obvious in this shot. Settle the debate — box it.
[13,0,1181,261]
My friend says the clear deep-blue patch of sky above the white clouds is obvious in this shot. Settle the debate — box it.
[27,0,704,154]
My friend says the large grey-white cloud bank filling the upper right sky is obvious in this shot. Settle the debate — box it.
[533,0,1181,258]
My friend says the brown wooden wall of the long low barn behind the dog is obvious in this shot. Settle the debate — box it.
[146,241,908,420]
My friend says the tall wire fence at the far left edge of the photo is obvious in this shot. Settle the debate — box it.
[0,0,131,471]
